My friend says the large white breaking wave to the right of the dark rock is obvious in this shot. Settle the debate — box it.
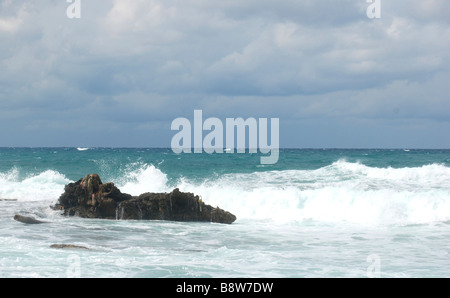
[174,161,450,224]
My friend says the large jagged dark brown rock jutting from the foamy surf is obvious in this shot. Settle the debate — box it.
[53,174,236,224]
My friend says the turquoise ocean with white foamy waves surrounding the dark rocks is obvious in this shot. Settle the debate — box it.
[0,148,450,278]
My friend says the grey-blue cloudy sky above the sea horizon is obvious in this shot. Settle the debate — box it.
[0,0,450,148]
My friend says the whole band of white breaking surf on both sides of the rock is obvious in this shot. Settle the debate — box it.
[0,160,450,225]
